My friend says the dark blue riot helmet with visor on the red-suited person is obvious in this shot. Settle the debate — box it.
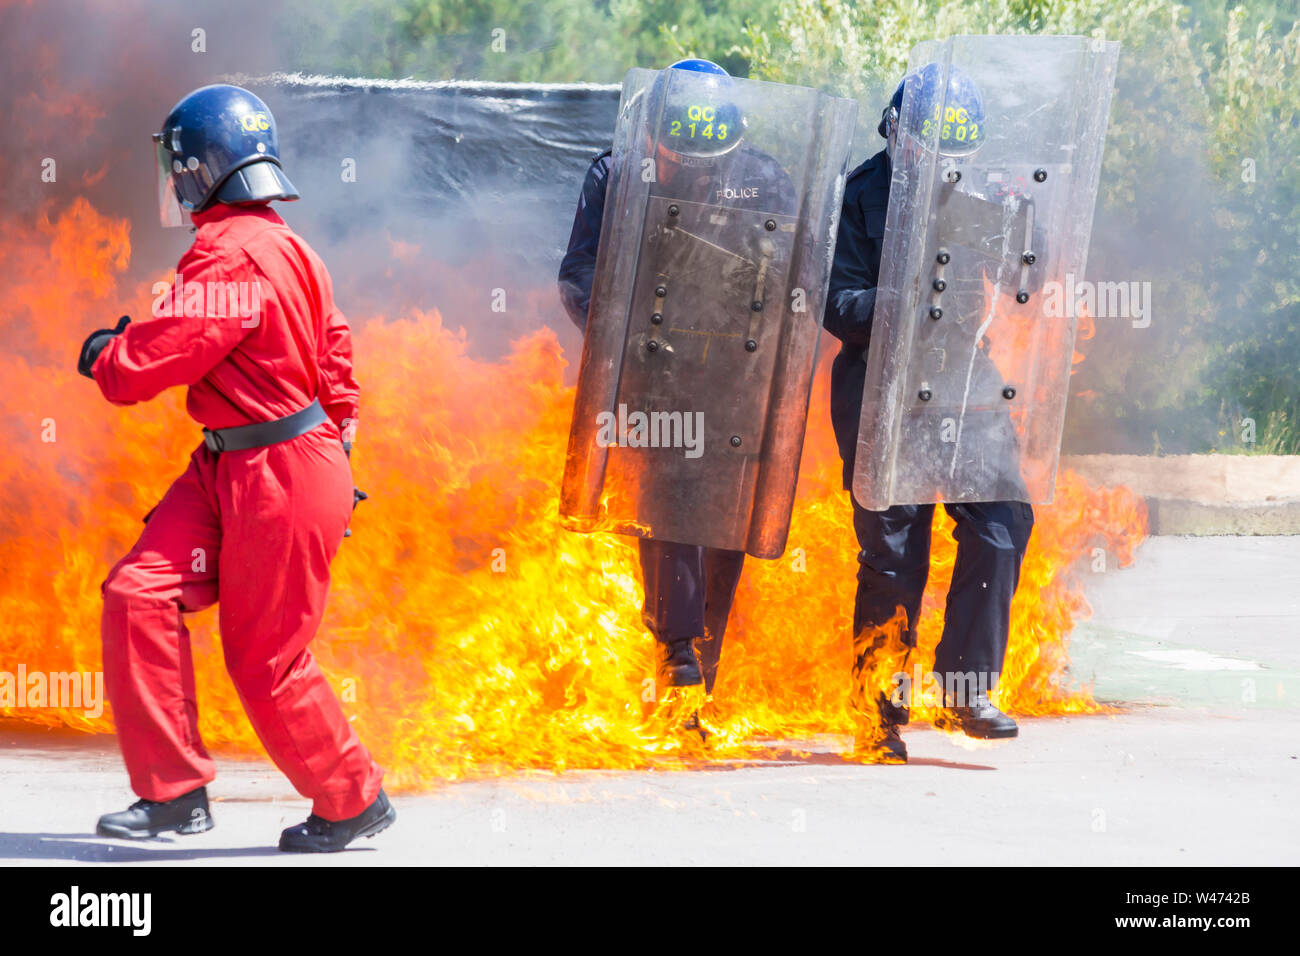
[153,83,298,226]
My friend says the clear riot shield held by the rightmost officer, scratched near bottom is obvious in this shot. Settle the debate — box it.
[853,36,1119,511]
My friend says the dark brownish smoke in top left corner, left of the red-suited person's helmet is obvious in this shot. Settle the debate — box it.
[0,0,284,268]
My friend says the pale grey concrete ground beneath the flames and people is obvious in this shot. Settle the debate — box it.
[0,537,1300,866]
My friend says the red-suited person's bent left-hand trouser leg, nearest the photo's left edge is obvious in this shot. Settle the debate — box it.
[101,449,221,800]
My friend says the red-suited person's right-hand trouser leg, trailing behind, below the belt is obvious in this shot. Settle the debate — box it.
[217,425,384,821]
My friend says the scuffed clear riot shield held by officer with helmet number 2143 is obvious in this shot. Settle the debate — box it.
[560,69,857,558]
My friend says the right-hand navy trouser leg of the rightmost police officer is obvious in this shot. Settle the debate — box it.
[935,501,1034,704]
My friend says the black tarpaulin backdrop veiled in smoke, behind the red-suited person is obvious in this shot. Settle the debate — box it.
[246,77,619,356]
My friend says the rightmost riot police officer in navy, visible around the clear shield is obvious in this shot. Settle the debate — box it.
[826,64,1034,763]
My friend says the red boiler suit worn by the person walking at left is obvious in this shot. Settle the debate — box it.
[92,204,384,821]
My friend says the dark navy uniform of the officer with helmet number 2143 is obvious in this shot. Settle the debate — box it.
[559,146,797,692]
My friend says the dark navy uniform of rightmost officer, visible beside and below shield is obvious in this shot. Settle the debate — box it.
[826,150,1034,675]
